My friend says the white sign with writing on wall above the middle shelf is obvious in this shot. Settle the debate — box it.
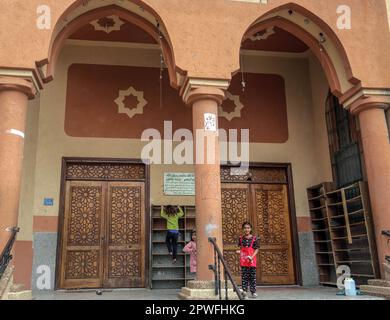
[164,172,195,196]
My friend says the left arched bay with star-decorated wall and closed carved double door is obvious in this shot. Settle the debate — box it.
[36,1,183,289]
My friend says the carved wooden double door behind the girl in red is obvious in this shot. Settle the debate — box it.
[222,183,295,285]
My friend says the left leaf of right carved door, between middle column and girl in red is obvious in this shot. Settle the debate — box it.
[222,183,250,284]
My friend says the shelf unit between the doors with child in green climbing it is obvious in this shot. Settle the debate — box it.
[150,205,195,289]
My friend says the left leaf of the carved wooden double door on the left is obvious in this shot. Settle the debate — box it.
[60,182,104,289]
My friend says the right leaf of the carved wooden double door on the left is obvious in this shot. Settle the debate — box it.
[104,182,145,288]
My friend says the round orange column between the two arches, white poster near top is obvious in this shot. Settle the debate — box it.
[187,88,224,281]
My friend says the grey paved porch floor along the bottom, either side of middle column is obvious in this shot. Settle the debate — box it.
[33,287,383,300]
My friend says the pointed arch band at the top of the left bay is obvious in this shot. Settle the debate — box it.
[44,0,181,87]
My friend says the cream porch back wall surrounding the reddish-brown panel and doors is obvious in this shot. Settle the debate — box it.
[21,44,331,222]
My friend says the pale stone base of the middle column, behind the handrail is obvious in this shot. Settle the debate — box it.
[178,280,238,300]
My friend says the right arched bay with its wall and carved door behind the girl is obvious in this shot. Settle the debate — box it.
[222,4,359,285]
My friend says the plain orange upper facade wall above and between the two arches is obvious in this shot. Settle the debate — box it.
[0,0,390,88]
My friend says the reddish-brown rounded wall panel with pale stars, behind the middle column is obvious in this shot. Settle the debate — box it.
[65,64,288,143]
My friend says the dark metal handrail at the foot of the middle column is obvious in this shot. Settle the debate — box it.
[209,237,243,300]
